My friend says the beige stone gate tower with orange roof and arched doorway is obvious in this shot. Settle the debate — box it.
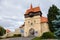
[24,4,42,37]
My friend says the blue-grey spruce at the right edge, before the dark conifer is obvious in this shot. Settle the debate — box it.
[52,10,60,38]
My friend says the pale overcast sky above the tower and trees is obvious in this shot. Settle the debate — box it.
[0,0,60,31]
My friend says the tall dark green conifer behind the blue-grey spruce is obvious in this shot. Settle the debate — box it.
[47,5,59,32]
